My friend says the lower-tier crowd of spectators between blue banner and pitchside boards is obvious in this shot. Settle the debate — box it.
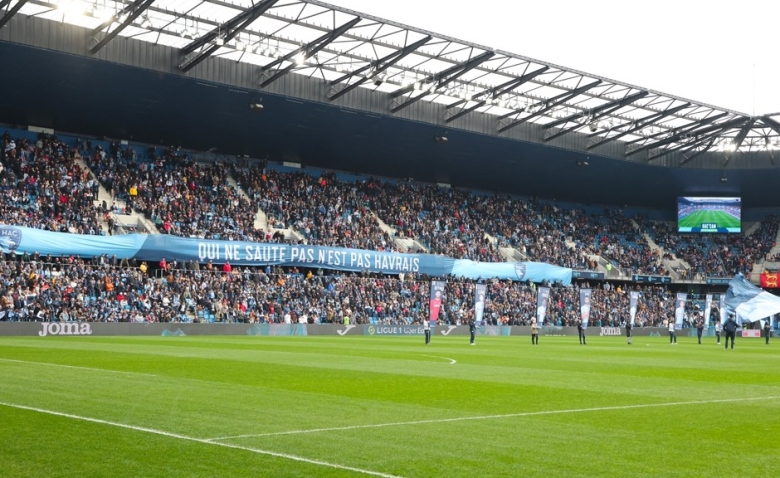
[0,250,717,327]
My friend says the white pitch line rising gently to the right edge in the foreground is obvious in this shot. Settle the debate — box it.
[206,396,780,442]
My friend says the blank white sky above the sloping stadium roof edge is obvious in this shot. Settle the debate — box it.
[324,0,780,115]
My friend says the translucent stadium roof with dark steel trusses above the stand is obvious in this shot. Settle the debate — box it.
[0,0,780,164]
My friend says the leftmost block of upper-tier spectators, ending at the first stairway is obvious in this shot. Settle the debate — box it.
[0,132,103,234]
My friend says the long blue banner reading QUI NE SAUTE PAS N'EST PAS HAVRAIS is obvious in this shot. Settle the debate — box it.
[0,225,572,285]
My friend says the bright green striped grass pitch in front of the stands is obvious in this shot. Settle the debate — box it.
[0,336,780,478]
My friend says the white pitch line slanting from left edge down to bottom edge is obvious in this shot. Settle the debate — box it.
[0,402,402,478]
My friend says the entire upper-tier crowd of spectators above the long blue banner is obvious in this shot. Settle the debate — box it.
[0,129,779,277]
